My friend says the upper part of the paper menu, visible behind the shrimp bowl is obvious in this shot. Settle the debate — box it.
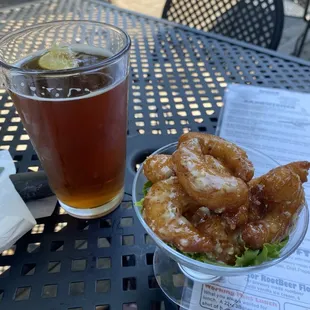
[217,85,310,198]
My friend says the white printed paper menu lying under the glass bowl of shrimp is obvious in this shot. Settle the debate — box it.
[184,85,310,310]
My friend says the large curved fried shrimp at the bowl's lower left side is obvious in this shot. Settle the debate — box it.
[142,177,215,253]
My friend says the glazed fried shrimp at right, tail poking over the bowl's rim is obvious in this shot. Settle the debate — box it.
[242,162,310,249]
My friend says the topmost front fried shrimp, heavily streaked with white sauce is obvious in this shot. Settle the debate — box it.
[172,138,248,213]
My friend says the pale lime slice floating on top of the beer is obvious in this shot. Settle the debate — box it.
[38,46,79,70]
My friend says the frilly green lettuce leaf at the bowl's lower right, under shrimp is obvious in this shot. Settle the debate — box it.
[235,237,288,267]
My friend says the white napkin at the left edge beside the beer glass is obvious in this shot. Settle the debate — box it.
[0,151,36,253]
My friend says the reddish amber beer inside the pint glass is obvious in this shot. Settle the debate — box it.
[11,71,127,208]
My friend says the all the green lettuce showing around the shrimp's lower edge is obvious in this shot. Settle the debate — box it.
[136,181,289,267]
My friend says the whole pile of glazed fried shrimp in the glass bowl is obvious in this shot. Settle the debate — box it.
[142,133,310,266]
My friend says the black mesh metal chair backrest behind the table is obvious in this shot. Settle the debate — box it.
[162,0,284,50]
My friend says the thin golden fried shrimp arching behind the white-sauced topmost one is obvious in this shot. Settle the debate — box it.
[179,132,254,182]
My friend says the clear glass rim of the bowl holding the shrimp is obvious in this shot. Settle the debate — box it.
[132,142,309,274]
